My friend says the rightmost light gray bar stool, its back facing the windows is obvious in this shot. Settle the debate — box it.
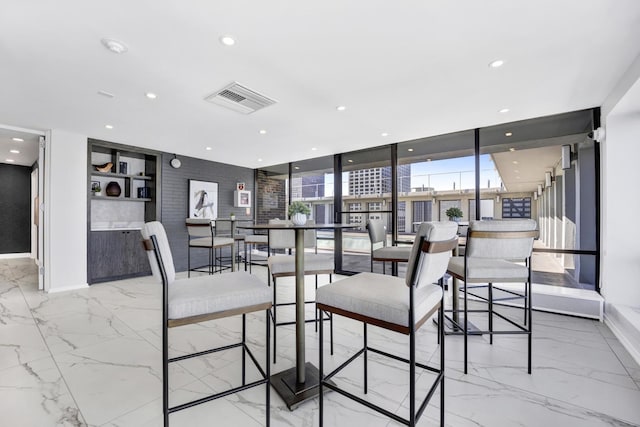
[447,219,538,374]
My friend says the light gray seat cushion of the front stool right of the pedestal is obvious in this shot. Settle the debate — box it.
[316,273,442,327]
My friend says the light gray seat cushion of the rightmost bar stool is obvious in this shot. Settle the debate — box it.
[448,257,529,283]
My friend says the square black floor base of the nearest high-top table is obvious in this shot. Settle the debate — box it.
[271,362,332,411]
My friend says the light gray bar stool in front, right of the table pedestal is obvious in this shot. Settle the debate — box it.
[316,221,458,426]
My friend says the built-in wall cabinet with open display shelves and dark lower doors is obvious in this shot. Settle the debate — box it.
[87,139,161,284]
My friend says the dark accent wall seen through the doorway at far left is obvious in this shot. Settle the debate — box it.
[0,163,31,254]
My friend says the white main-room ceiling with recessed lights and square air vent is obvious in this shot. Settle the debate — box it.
[0,0,640,168]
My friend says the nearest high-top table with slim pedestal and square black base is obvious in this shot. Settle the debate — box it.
[237,223,354,410]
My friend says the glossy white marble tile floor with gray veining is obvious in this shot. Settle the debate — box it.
[0,259,640,427]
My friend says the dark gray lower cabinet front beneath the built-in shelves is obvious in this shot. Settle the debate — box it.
[88,230,151,283]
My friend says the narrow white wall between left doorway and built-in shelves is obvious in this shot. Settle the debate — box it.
[44,129,87,292]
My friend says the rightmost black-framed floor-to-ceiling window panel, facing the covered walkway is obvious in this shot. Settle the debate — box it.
[480,110,597,290]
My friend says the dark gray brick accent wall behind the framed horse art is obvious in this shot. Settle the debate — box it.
[161,153,255,271]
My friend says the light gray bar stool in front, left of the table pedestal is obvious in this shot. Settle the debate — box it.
[141,221,271,427]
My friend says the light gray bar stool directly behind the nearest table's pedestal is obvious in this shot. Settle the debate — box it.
[267,219,335,363]
